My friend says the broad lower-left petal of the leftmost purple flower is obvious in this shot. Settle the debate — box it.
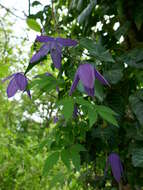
[7,78,18,98]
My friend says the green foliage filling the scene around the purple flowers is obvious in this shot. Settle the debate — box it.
[0,0,143,190]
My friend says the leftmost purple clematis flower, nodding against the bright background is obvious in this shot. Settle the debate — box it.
[2,73,31,98]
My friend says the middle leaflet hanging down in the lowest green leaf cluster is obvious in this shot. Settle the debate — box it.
[61,149,71,169]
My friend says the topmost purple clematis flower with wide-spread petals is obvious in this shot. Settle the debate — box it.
[30,36,77,69]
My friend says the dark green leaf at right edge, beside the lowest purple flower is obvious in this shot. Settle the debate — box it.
[132,148,143,168]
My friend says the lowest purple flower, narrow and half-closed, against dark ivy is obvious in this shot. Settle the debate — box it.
[105,153,123,183]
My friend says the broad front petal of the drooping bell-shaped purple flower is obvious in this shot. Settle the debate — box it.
[78,64,95,89]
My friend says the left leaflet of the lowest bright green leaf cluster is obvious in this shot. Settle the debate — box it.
[43,152,59,176]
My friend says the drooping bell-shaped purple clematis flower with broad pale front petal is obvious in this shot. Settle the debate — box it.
[69,63,110,96]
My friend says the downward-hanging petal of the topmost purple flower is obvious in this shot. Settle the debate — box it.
[50,44,62,69]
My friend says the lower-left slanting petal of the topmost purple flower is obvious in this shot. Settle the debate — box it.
[30,44,50,63]
